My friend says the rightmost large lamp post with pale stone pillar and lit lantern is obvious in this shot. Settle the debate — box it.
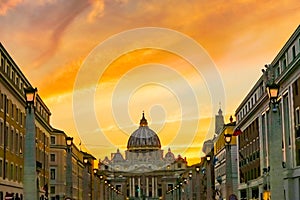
[267,82,284,200]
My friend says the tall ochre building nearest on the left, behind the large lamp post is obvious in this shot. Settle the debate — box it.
[0,43,51,200]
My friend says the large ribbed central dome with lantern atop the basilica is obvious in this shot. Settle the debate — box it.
[127,113,161,151]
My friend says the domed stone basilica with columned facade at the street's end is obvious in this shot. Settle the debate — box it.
[97,113,192,200]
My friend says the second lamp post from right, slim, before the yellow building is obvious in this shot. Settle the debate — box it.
[224,133,233,199]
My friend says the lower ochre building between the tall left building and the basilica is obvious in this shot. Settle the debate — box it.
[49,129,96,200]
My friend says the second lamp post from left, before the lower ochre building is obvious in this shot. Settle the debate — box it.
[66,137,73,199]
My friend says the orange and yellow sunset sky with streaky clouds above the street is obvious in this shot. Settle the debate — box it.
[0,0,300,164]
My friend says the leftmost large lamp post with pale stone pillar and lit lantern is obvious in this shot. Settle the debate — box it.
[23,87,39,200]
